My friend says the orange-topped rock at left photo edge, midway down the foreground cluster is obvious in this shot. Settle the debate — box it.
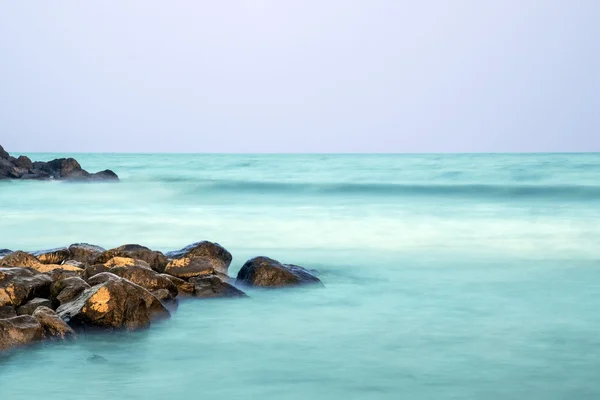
[0,268,52,307]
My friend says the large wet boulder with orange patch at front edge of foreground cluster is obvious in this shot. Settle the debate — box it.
[58,272,169,330]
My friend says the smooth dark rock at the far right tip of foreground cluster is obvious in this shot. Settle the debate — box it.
[236,257,321,287]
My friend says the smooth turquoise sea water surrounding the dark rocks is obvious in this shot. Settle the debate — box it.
[0,154,600,400]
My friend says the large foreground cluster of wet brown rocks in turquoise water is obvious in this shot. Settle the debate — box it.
[0,241,321,351]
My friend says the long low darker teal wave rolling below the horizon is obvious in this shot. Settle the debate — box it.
[184,180,600,200]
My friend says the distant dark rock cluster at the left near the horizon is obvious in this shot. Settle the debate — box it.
[0,146,119,181]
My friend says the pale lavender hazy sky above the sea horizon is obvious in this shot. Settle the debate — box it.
[0,0,600,153]
